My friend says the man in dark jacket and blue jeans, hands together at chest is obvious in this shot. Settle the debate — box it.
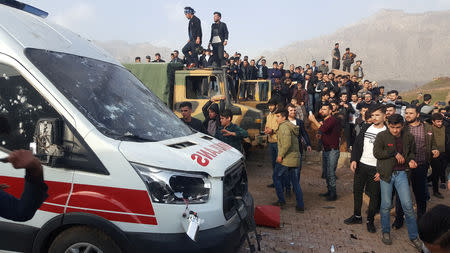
[373,114,422,252]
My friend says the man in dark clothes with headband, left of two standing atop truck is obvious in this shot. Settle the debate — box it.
[182,7,202,67]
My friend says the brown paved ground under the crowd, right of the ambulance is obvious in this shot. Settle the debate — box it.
[238,149,450,253]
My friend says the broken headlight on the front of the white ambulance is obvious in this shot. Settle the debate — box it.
[131,163,211,204]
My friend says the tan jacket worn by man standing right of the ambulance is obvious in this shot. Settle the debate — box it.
[277,120,300,168]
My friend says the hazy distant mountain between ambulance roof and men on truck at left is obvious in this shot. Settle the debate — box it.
[94,40,172,63]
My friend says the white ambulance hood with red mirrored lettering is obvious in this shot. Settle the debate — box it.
[119,133,243,177]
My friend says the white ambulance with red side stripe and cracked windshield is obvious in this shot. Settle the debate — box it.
[0,0,254,253]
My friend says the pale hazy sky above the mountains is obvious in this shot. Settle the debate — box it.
[23,0,450,56]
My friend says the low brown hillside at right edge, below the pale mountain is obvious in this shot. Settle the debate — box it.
[400,77,450,105]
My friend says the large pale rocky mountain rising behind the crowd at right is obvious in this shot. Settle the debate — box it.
[263,10,450,90]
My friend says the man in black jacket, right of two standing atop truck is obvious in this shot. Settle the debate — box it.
[208,11,228,67]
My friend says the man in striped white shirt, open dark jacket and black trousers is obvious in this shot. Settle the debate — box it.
[344,105,386,233]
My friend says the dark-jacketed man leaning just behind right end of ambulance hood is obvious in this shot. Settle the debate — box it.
[215,109,248,153]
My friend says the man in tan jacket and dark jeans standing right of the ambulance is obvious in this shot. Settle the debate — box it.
[275,109,304,212]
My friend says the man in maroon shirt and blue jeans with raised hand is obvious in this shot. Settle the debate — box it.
[309,102,341,201]
